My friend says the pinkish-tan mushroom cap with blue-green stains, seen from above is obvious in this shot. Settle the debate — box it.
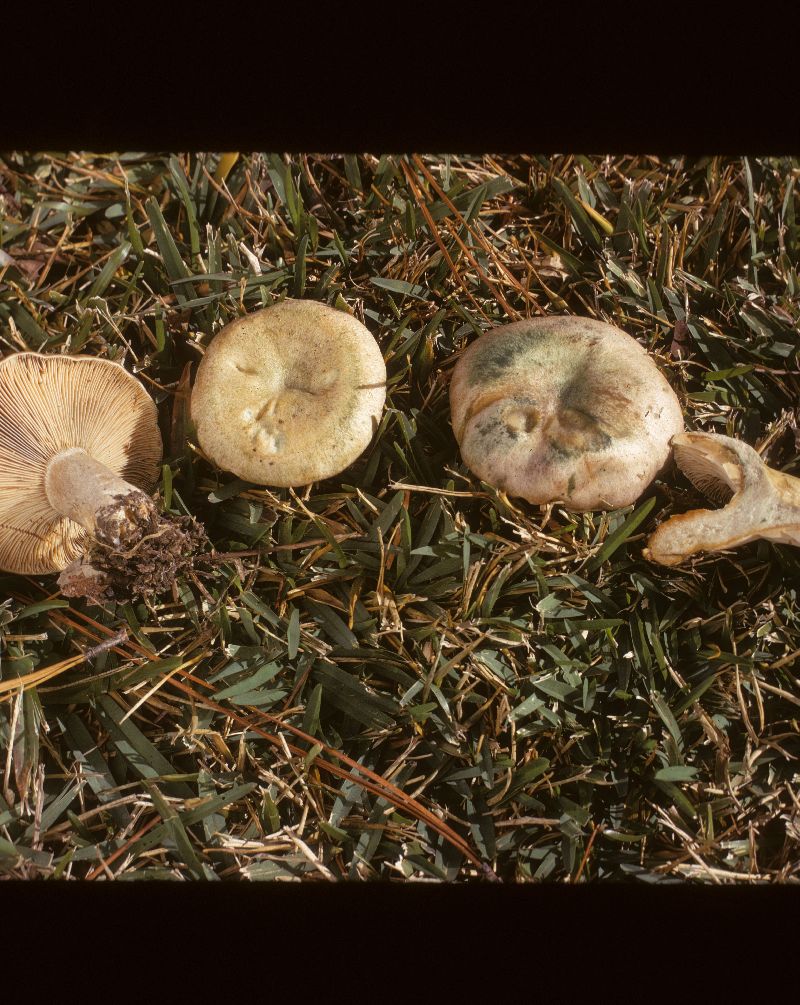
[450,317,683,511]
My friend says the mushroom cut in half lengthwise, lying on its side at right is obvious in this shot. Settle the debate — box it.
[642,433,800,566]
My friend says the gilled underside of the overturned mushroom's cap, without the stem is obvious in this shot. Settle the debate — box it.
[0,353,162,575]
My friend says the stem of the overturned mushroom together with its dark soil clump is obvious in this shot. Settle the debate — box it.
[44,448,205,603]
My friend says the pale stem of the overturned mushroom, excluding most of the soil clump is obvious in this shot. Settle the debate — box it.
[44,447,158,549]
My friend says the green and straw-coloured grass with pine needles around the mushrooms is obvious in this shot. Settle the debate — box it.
[0,153,800,883]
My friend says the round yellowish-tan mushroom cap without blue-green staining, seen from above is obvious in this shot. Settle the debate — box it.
[191,299,386,486]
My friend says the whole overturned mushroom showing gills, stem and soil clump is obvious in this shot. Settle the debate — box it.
[0,353,205,602]
